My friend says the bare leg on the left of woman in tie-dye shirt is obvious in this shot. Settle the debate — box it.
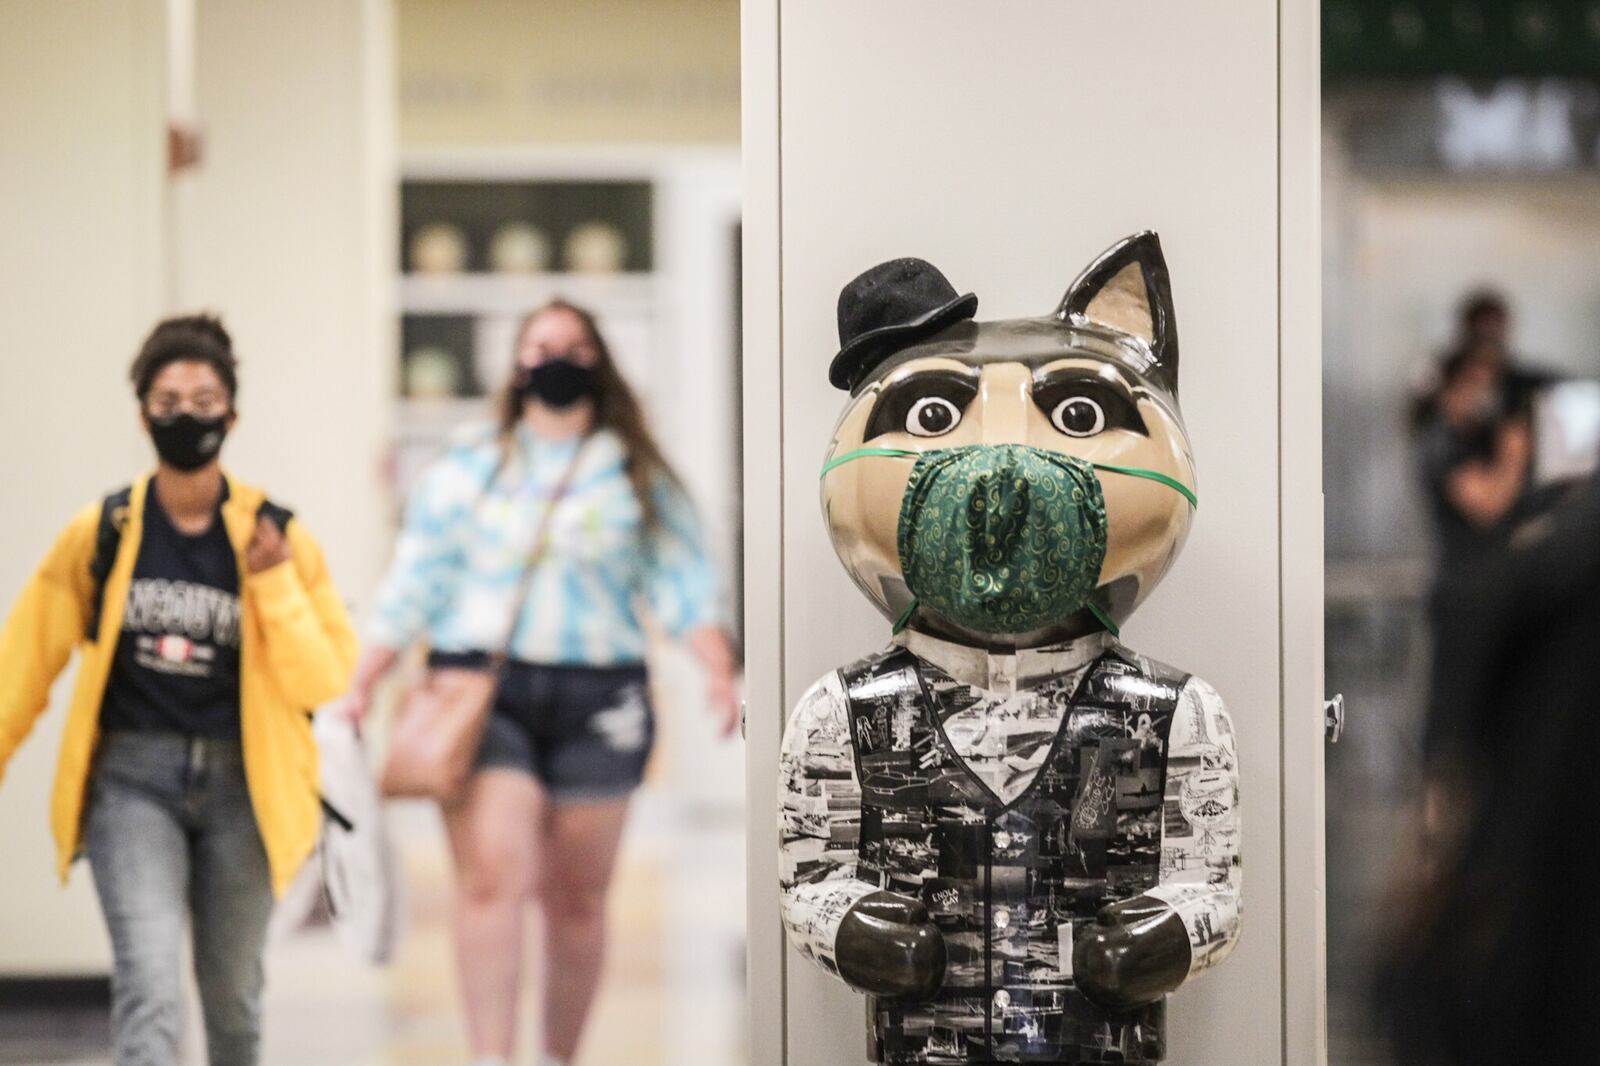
[445,770,544,1058]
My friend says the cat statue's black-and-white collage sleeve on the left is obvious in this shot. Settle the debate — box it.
[778,674,878,975]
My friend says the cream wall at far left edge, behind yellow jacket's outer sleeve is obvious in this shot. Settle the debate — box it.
[0,0,166,976]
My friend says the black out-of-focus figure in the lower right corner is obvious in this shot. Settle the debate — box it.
[1376,467,1600,1066]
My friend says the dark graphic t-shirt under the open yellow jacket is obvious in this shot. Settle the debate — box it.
[101,488,238,738]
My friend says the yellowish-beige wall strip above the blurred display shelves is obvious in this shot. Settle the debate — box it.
[398,0,739,147]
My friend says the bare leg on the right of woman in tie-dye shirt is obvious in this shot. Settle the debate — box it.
[541,799,627,1063]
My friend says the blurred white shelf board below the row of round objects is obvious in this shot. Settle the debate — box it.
[400,272,658,317]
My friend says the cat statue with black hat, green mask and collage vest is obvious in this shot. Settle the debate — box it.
[779,232,1242,1066]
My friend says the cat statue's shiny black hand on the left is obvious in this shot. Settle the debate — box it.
[834,892,944,1000]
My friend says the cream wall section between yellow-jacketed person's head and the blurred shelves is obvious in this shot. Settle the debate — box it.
[173,0,397,608]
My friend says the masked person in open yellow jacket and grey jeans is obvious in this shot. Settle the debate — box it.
[0,315,357,1066]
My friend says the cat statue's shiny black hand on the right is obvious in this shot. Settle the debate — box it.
[1072,896,1189,1010]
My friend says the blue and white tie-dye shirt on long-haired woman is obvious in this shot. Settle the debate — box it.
[366,427,718,666]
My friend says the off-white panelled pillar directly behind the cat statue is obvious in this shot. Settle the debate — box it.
[744,0,1320,1066]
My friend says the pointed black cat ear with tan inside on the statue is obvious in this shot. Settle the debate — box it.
[1056,230,1178,395]
